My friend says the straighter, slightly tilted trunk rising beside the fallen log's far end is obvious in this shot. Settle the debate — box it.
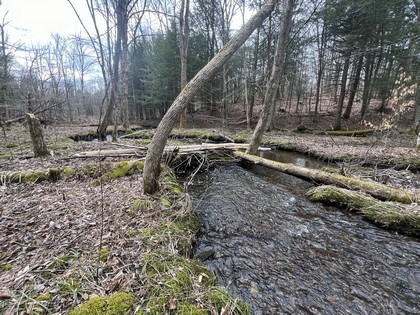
[247,0,294,154]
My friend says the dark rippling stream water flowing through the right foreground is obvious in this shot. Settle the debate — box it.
[190,158,420,315]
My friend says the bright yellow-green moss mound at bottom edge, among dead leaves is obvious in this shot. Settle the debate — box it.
[69,292,136,315]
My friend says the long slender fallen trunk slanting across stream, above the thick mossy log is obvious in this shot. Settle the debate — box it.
[234,151,419,204]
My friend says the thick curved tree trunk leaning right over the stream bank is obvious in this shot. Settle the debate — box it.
[143,0,277,194]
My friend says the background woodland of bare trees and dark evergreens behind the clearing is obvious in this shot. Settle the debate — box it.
[0,0,420,133]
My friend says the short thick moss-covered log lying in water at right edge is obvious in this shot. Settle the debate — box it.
[307,186,420,236]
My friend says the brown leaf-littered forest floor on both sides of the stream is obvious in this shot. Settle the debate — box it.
[0,103,420,315]
